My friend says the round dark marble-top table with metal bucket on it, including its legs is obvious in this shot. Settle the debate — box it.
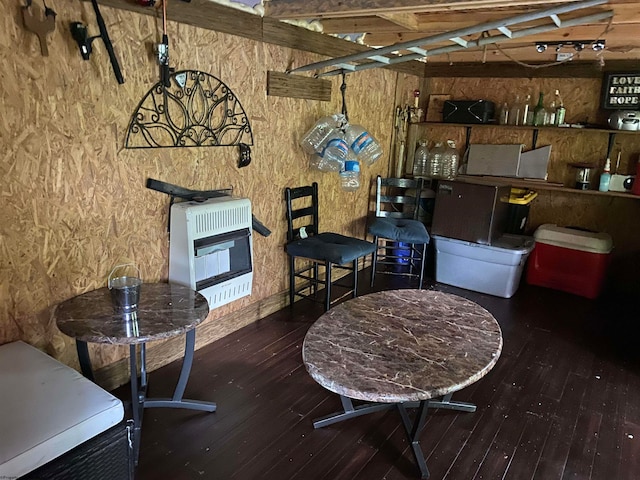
[52,283,216,464]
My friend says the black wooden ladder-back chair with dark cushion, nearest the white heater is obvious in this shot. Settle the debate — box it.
[285,182,375,310]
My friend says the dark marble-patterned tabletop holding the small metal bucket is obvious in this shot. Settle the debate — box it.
[53,283,209,345]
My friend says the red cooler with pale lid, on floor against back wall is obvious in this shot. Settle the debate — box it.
[526,224,613,298]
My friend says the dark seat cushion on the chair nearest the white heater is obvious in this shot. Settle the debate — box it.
[285,232,375,265]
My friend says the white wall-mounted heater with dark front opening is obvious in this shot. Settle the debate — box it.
[169,196,253,310]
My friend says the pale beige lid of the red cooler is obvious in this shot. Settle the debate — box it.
[533,223,613,253]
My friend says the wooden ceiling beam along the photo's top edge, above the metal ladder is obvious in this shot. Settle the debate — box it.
[265,0,575,19]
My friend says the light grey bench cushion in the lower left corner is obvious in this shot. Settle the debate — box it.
[0,341,124,478]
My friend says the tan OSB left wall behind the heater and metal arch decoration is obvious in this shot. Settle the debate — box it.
[0,0,397,382]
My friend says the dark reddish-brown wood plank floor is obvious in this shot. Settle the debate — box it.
[114,271,640,480]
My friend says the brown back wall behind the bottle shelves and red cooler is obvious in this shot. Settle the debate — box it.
[421,78,640,283]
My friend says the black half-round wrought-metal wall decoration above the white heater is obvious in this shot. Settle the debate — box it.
[125,70,253,167]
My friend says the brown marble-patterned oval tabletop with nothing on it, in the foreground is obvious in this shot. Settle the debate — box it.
[302,289,502,403]
